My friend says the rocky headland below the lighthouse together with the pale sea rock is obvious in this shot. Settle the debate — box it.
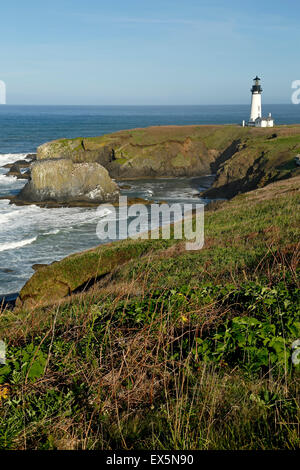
[9,125,300,205]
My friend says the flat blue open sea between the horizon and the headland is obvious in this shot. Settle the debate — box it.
[0,103,300,154]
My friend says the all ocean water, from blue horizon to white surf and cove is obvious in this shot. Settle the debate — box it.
[0,105,300,295]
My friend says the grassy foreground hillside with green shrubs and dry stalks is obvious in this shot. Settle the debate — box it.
[0,174,300,449]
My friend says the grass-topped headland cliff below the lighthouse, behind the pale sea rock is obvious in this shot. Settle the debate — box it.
[37,125,300,198]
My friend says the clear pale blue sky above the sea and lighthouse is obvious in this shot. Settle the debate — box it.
[0,0,300,105]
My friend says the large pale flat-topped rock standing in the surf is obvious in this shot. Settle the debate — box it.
[18,159,119,203]
